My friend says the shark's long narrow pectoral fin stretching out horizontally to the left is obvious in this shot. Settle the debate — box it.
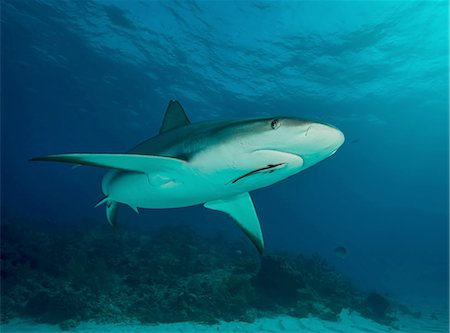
[31,154,186,173]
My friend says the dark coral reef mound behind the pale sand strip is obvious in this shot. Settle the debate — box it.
[1,217,398,330]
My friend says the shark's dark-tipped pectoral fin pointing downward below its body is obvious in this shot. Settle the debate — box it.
[204,192,264,253]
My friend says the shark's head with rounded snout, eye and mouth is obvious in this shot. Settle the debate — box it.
[196,117,344,191]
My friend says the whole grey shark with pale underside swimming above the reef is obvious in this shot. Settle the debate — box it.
[31,100,345,253]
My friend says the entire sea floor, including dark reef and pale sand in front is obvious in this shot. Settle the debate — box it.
[0,221,449,333]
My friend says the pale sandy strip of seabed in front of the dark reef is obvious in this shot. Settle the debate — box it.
[1,309,449,333]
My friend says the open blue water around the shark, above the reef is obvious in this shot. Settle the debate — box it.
[1,0,449,328]
